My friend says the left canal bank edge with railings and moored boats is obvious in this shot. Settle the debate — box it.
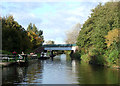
[0,54,38,67]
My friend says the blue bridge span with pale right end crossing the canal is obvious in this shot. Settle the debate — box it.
[43,44,77,52]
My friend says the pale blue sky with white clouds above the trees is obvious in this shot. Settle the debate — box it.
[0,0,108,44]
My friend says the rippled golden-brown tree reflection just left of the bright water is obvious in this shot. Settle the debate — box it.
[21,61,43,83]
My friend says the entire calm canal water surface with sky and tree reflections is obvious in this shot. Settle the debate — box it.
[2,54,120,85]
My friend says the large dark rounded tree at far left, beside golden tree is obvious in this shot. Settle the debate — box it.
[2,16,32,53]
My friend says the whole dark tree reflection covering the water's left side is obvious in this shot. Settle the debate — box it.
[2,61,43,85]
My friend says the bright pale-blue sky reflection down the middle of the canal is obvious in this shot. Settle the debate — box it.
[42,54,76,84]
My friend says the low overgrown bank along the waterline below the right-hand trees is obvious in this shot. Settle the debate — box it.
[70,51,120,69]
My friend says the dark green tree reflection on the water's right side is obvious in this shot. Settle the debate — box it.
[76,63,118,84]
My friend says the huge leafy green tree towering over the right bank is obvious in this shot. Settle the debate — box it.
[77,2,120,63]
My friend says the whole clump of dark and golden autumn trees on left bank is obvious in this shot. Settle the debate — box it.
[1,16,43,53]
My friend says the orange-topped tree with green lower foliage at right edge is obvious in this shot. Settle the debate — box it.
[105,28,120,64]
